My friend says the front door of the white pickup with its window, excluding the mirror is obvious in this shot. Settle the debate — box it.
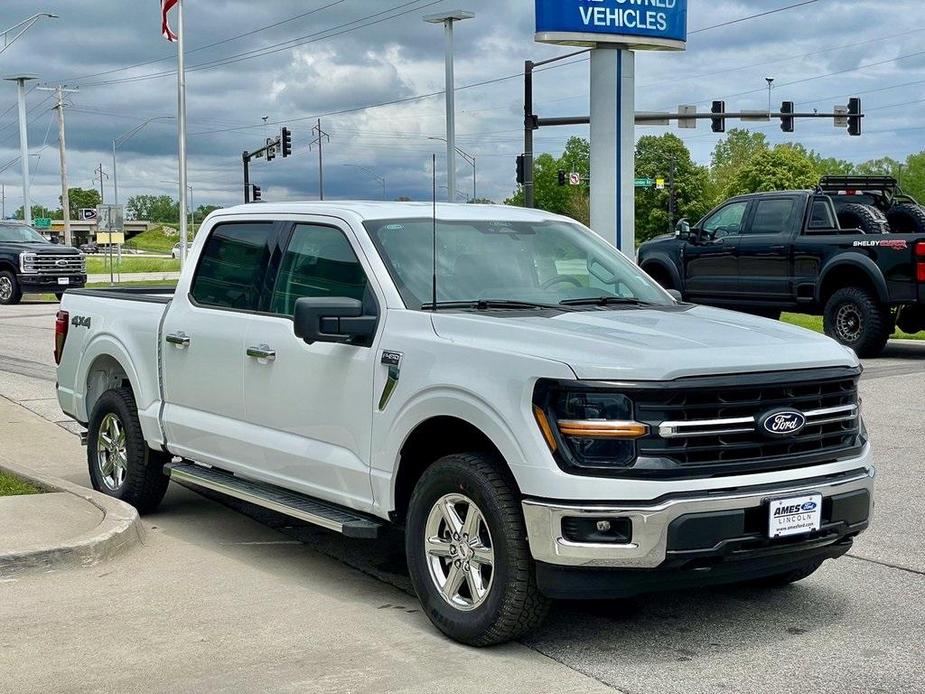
[244,221,384,510]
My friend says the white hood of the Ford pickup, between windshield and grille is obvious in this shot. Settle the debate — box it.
[433,306,858,381]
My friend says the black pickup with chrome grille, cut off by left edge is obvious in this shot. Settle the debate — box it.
[0,222,87,306]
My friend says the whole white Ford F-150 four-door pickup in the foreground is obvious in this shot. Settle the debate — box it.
[55,203,874,645]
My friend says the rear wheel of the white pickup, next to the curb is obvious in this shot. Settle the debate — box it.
[87,388,170,513]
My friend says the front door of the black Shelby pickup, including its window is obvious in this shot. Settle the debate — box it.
[683,200,749,303]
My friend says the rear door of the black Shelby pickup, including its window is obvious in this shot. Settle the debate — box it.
[736,195,806,303]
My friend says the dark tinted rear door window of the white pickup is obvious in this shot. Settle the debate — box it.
[190,222,273,311]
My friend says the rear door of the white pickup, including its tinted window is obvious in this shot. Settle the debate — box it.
[161,222,278,469]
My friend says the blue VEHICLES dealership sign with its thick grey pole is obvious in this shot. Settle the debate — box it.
[536,0,687,256]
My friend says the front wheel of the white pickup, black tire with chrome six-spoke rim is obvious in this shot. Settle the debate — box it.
[405,453,549,646]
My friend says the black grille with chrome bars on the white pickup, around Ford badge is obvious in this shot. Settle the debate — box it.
[633,369,862,477]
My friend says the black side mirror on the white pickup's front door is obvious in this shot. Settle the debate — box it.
[293,296,379,347]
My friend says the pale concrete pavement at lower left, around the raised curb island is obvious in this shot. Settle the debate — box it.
[0,400,613,694]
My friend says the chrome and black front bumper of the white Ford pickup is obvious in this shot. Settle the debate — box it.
[523,467,875,570]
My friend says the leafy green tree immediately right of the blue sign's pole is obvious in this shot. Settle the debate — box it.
[636,133,710,242]
